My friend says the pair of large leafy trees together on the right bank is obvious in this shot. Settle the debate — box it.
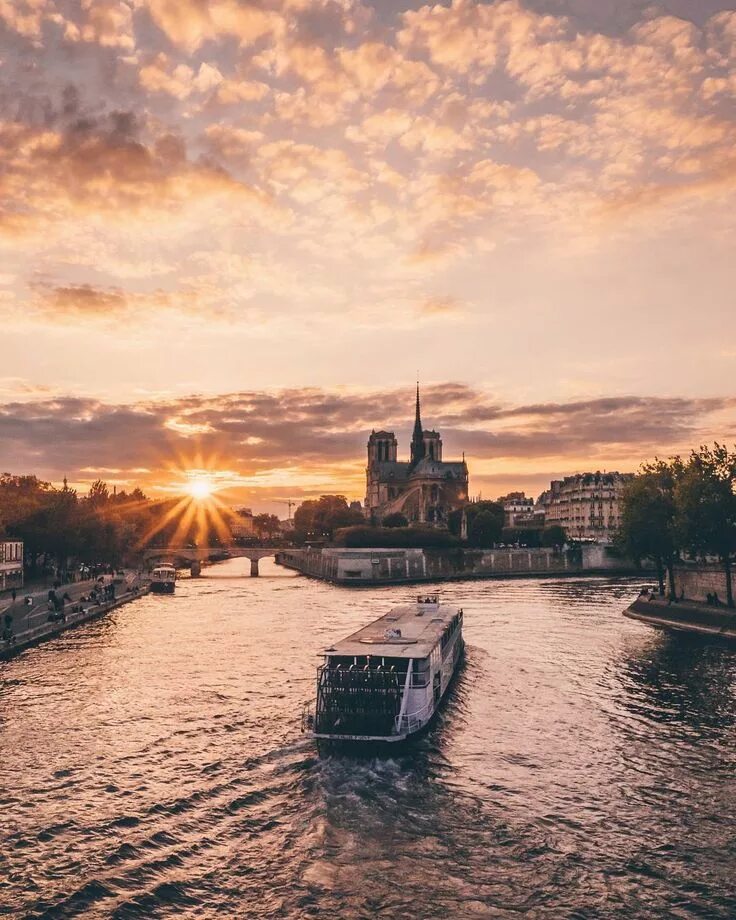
[617,443,736,607]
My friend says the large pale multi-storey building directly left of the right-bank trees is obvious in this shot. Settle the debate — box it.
[537,473,634,543]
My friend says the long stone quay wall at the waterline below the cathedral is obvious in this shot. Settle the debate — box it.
[277,545,637,585]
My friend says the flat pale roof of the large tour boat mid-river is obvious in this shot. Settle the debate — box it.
[325,595,460,658]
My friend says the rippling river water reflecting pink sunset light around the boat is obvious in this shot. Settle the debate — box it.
[0,560,736,920]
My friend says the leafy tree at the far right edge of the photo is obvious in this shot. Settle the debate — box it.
[675,443,736,607]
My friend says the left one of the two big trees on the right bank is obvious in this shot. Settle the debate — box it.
[616,457,682,596]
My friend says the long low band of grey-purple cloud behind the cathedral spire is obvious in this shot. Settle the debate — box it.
[0,382,736,501]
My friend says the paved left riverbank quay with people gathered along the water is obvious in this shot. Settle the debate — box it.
[0,577,149,661]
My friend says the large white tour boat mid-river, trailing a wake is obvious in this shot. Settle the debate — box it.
[308,595,464,743]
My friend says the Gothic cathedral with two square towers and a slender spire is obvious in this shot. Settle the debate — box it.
[365,384,468,527]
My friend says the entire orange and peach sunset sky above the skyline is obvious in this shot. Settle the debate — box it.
[0,0,736,506]
